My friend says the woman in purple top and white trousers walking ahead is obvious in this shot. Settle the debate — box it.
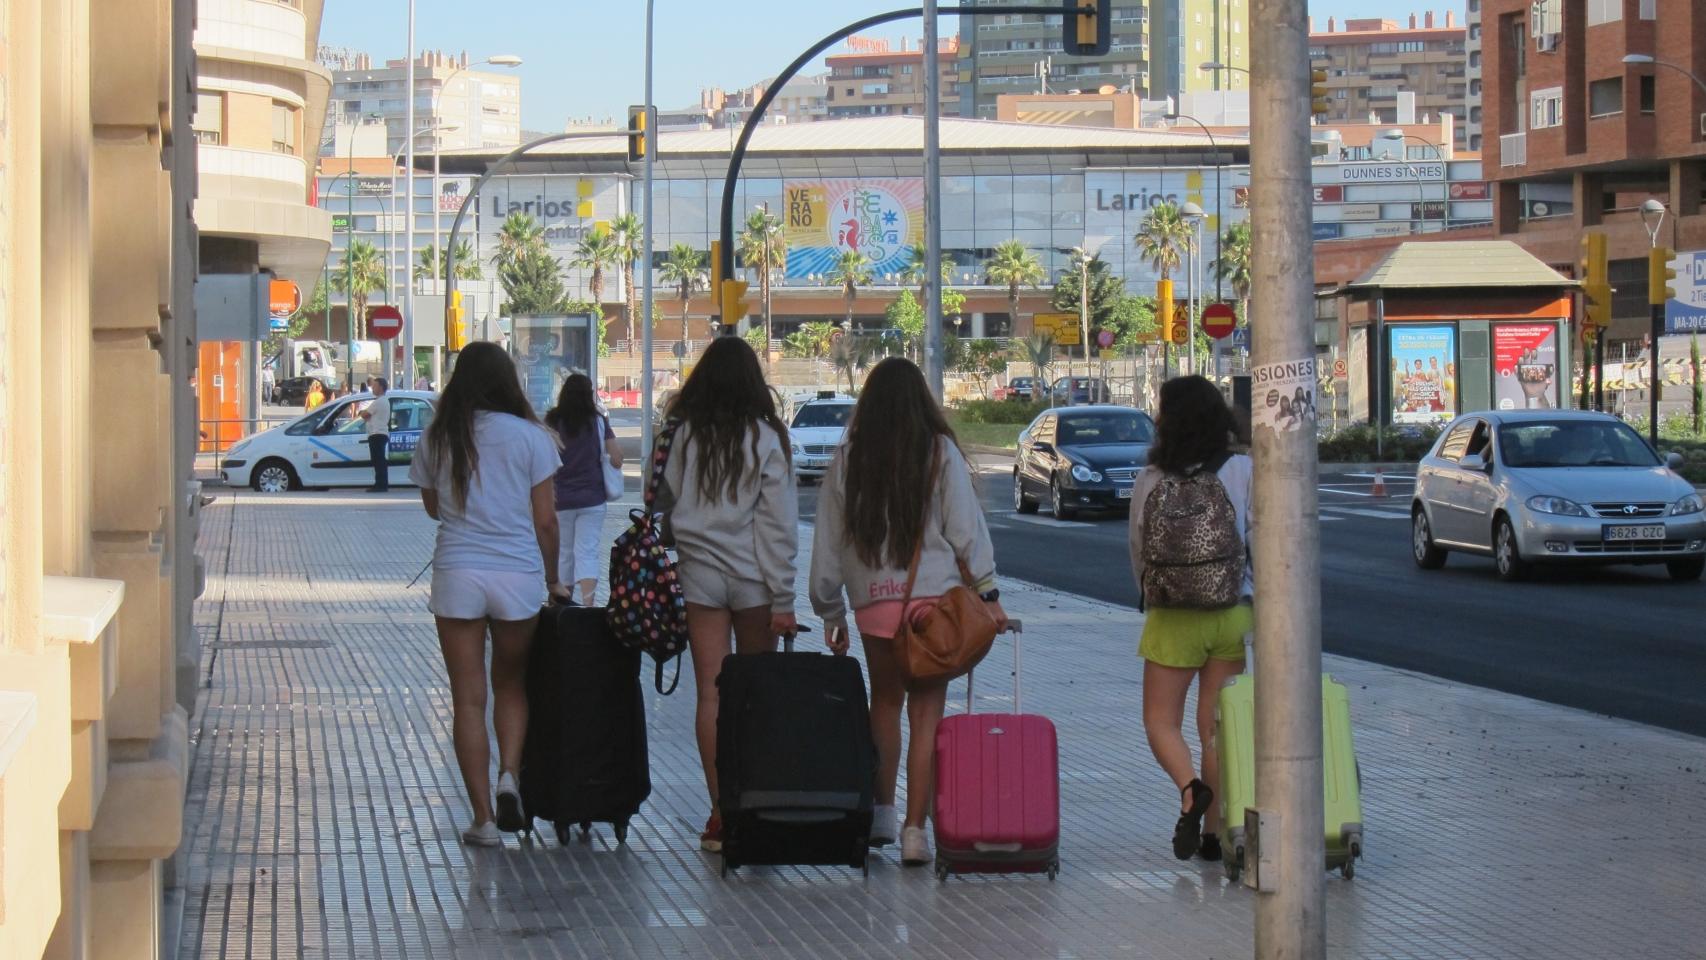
[544,373,623,607]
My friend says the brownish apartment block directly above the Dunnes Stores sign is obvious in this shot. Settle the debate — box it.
[1309,10,1469,148]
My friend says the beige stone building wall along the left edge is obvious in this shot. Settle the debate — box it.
[0,0,196,960]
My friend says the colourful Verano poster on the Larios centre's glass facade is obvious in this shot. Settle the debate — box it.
[783,179,925,280]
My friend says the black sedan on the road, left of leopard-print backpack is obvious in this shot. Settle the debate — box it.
[1013,406,1155,520]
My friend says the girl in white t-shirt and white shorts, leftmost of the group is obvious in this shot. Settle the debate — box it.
[409,343,566,846]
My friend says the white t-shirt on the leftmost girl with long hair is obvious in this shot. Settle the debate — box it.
[409,411,561,581]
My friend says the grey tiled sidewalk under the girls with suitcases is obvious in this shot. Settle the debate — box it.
[181,491,1706,960]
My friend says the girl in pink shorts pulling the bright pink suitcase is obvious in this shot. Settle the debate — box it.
[810,356,1007,865]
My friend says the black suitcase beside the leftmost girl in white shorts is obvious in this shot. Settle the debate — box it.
[520,604,652,842]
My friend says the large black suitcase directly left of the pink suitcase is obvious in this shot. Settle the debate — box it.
[717,643,877,875]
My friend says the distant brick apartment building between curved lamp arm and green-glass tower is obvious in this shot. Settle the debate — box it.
[824,38,959,119]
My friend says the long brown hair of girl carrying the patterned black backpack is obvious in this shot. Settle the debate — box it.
[665,336,793,503]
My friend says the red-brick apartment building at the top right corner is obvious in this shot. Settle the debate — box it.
[1481,0,1706,343]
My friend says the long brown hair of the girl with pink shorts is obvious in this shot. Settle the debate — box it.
[841,356,964,568]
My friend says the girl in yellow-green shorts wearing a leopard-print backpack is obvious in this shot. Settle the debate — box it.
[1129,377,1255,859]
